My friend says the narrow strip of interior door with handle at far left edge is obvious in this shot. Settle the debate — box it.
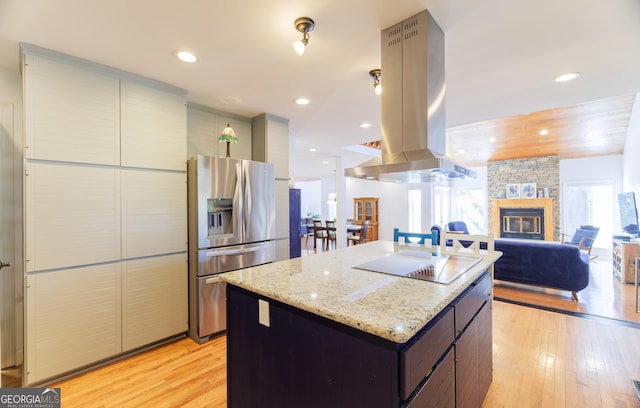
[0,104,19,368]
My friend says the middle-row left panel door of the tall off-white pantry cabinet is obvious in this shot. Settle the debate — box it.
[25,163,120,272]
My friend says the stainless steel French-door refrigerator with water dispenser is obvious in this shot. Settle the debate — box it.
[187,156,276,343]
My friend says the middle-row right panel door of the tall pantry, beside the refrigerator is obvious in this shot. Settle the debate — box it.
[122,169,187,259]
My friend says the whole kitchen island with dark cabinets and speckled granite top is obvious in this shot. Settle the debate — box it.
[221,241,500,408]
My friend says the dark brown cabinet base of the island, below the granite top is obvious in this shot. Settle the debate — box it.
[227,272,492,408]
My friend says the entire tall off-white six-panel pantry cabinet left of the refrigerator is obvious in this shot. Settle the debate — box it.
[21,44,188,385]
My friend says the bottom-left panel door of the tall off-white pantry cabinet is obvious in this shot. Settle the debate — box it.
[24,263,122,384]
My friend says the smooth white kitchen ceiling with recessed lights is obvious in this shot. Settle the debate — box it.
[0,0,640,178]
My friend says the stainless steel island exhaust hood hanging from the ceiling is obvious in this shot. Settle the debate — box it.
[345,10,476,183]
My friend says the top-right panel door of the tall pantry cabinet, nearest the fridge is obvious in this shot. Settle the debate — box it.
[121,81,187,170]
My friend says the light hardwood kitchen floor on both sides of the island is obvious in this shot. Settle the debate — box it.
[50,301,640,408]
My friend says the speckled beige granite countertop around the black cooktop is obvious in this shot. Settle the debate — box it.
[220,241,501,344]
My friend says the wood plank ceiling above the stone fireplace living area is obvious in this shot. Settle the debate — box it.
[447,94,635,167]
